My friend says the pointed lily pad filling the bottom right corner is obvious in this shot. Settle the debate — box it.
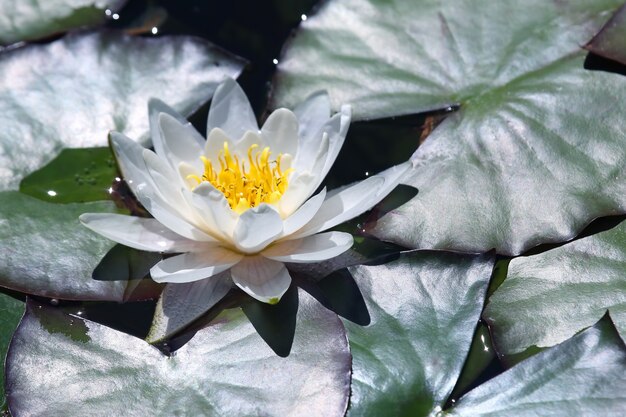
[444,316,626,417]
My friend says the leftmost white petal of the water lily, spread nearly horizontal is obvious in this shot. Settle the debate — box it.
[79,213,201,253]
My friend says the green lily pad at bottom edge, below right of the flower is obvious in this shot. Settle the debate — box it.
[345,252,494,416]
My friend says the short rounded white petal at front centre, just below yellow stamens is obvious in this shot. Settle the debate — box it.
[233,203,283,253]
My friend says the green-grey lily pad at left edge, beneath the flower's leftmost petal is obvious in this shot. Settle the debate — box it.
[0,191,127,301]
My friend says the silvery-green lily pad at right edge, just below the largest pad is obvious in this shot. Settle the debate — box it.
[483,221,626,355]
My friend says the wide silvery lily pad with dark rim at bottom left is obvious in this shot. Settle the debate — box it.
[7,292,350,417]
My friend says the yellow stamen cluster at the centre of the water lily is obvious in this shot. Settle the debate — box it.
[187,142,293,214]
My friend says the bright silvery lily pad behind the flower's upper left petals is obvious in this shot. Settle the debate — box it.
[0,32,243,190]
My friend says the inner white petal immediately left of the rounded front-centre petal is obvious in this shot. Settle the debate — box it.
[191,181,239,242]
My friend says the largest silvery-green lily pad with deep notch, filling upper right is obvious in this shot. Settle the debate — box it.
[273,0,626,255]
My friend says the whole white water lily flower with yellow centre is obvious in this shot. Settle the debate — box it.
[80,80,409,304]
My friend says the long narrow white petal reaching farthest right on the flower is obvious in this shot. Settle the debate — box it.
[290,162,411,238]
